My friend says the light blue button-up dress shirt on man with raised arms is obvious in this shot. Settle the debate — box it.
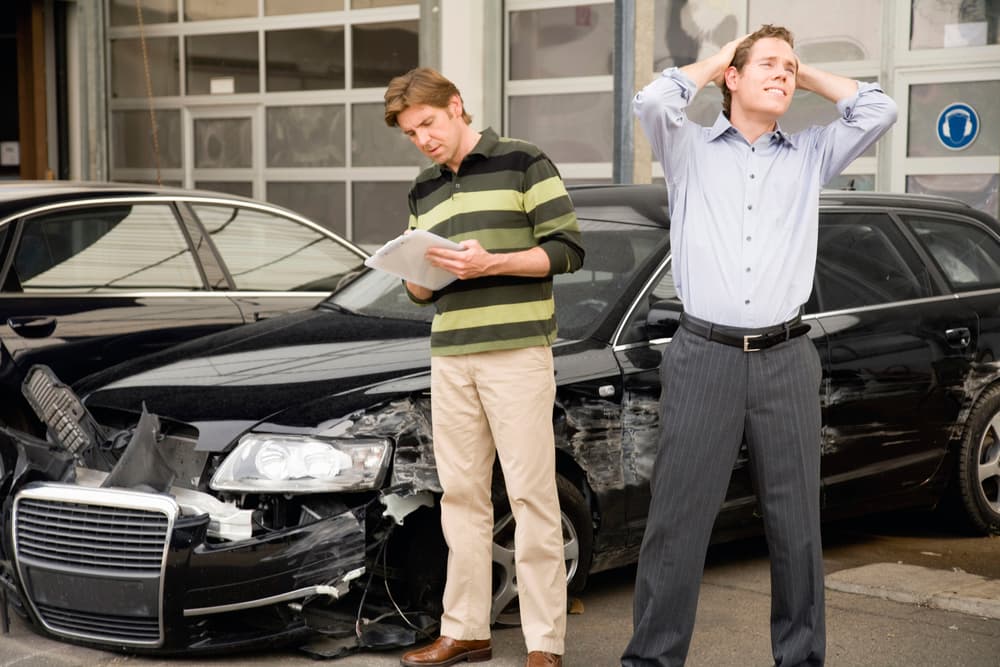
[632,68,896,328]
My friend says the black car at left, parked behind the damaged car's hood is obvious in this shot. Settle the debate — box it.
[0,181,367,430]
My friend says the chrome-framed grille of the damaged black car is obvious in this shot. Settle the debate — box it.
[13,483,178,646]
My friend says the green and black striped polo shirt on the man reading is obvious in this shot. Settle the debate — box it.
[409,129,584,356]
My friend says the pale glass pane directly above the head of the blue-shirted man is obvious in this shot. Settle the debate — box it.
[748,0,882,63]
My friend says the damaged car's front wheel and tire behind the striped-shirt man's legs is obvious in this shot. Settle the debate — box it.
[490,474,594,626]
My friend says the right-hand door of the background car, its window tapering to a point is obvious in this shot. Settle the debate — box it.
[191,201,364,321]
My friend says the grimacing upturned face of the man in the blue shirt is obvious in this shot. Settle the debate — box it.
[726,37,799,120]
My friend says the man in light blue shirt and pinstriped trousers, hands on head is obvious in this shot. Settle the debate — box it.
[622,25,896,667]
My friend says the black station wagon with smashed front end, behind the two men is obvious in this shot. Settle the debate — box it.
[0,186,1000,656]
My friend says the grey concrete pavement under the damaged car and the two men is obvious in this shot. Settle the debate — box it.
[0,552,1000,667]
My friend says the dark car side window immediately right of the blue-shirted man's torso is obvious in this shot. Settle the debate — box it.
[806,213,931,313]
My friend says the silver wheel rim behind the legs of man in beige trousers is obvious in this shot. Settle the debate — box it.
[490,512,580,625]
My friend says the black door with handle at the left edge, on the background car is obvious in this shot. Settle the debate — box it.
[0,199,244,428]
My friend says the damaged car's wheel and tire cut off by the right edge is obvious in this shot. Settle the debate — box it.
[954,385,1000,535]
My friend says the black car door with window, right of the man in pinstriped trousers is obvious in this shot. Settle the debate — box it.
[809,209,978,516]
